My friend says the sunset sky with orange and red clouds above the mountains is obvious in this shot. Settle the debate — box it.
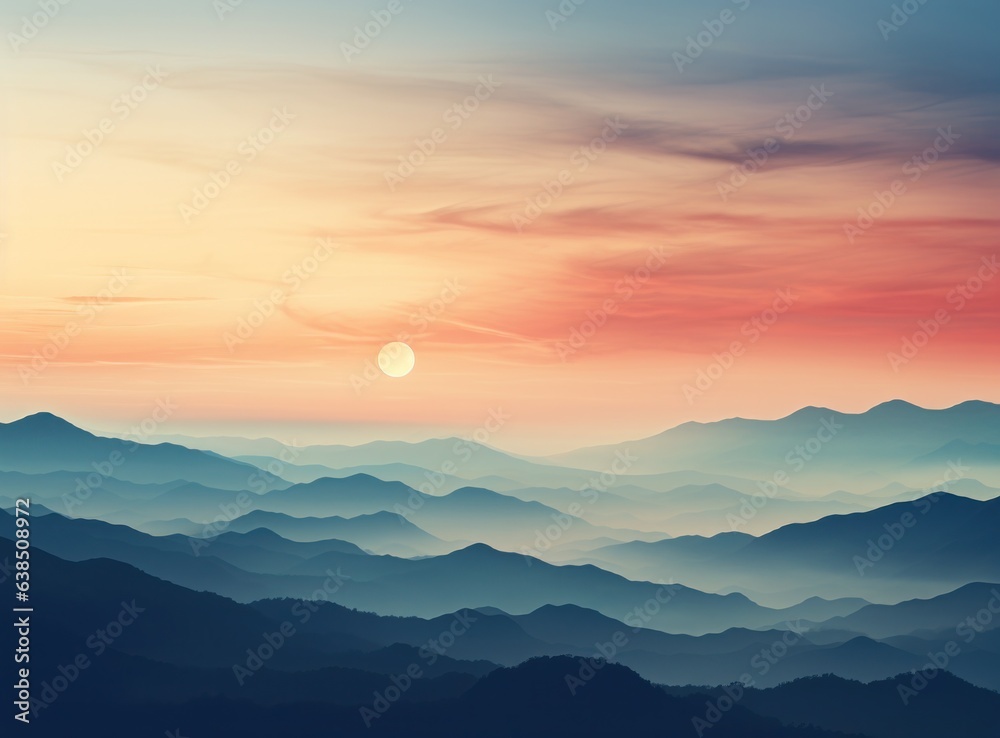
[0,0,1000,453]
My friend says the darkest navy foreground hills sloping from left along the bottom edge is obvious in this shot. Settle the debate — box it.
[9,539,1000,738]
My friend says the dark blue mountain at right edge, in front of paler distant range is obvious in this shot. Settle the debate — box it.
[576,493,1000,604]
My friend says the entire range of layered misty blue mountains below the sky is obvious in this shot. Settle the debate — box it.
[7,402,1000,738]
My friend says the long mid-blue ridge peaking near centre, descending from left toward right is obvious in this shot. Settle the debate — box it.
[0,506,772,634]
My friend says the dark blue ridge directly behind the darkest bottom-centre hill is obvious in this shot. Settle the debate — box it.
[254,600,948,686]
